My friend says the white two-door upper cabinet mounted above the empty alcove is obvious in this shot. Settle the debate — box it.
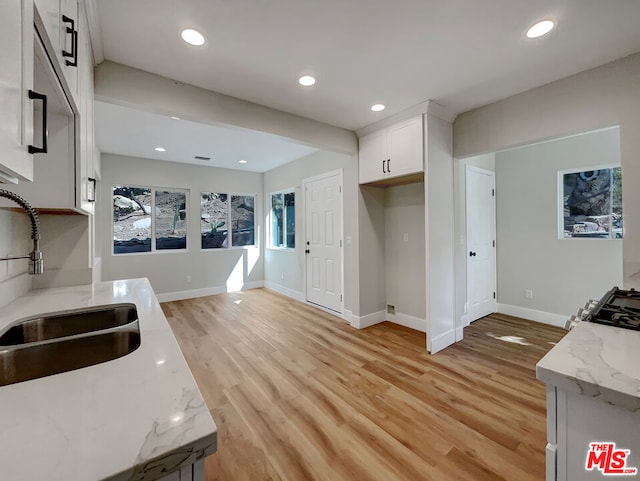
[358,115,424,184]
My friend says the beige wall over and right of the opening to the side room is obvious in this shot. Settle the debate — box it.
[453,54,640,288]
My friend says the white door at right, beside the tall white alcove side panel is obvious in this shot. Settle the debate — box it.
[466,166,497,322]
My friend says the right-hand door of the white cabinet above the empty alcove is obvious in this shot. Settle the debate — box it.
[386,116,424,177]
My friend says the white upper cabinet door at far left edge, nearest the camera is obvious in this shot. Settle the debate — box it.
[0,0,33,182]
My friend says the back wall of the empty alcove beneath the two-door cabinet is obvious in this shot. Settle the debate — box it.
[384,183,427,324]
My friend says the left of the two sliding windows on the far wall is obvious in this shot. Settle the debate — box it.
[113,186,187,254]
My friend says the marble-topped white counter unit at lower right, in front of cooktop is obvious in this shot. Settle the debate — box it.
[536,322,640,481]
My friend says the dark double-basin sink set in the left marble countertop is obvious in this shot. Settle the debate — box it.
[0,304,140,386]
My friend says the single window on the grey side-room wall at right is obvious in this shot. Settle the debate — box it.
[559,167,622,239]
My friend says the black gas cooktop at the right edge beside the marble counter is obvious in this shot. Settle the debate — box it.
[584,287,640,331]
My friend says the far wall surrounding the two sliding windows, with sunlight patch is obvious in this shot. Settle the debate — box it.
[97,154,264,299]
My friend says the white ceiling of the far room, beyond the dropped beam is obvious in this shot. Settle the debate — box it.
[95,102,318,172]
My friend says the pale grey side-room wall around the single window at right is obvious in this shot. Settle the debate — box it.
[495,129,626,317]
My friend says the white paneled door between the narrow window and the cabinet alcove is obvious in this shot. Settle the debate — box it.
[304,173,342,313]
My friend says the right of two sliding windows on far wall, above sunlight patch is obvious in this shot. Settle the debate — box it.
[200,192,256,249]
